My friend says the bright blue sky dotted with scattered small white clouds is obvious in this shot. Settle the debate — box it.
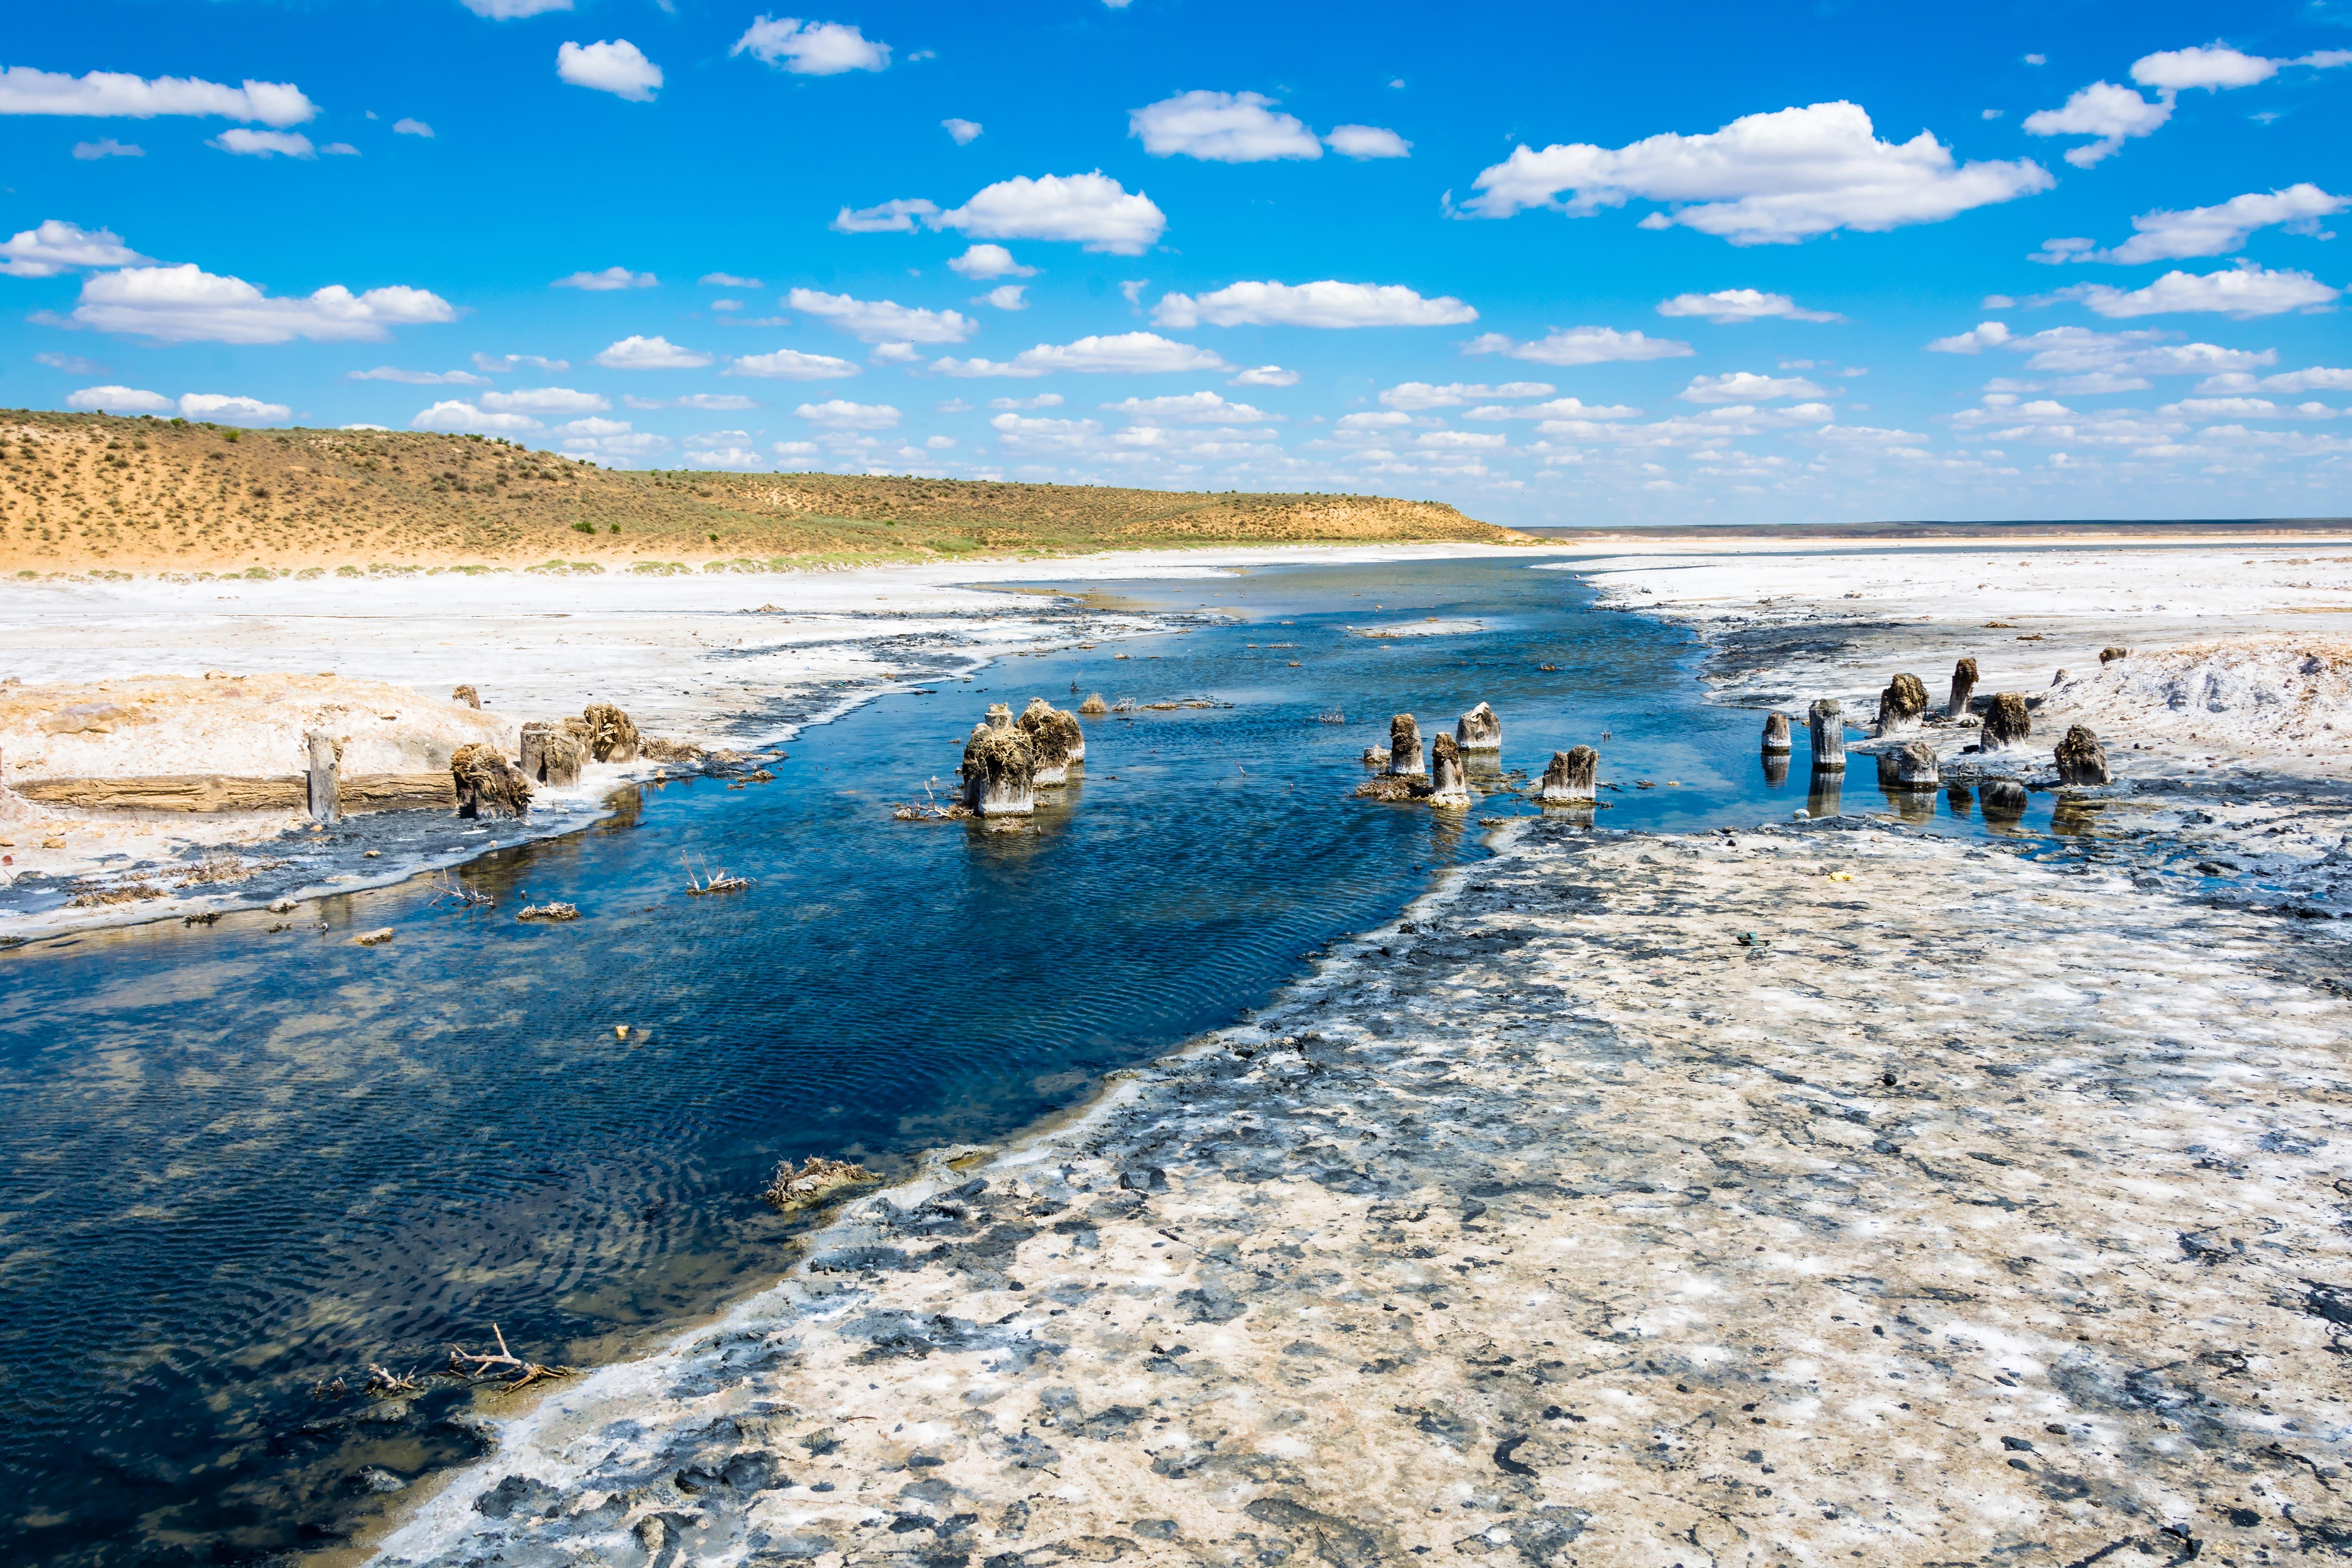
[0,0,2352,524]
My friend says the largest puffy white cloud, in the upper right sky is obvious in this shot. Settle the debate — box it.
[1467,103,2053,244]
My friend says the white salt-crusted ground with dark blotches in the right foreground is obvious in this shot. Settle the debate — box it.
[390,823,2352,1568]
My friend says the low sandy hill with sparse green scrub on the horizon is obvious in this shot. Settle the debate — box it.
[0,411,1531,573]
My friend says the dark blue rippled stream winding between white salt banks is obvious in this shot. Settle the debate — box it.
[0,562,2098,1563]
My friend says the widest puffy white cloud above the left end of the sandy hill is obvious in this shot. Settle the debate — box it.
[68,263,456,343]
